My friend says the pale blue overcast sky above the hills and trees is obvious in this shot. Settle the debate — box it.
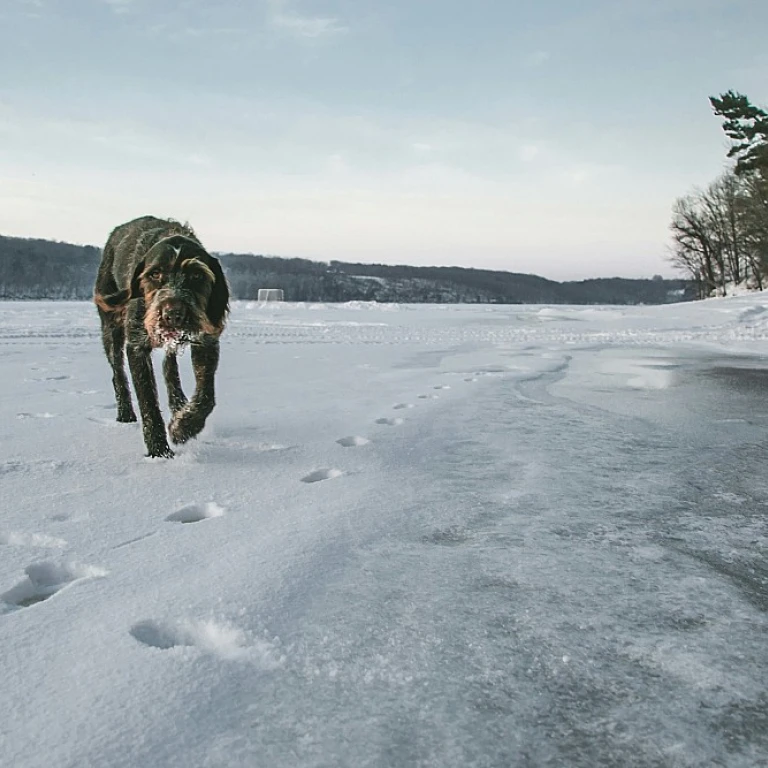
[0,0,768,280]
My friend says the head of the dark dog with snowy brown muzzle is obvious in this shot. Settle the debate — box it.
[131,235,229,347]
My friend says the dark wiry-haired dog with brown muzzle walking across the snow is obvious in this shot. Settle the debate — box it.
[94,216,229,458]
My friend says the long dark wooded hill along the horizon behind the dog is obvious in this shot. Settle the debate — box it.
[0,235,694,304]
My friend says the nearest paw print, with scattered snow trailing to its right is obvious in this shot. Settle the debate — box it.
[130,619,285,669]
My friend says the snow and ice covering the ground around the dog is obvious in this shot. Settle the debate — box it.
[0,295,768,768]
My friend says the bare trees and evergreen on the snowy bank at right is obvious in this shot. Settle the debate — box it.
[670,90,768,298]
